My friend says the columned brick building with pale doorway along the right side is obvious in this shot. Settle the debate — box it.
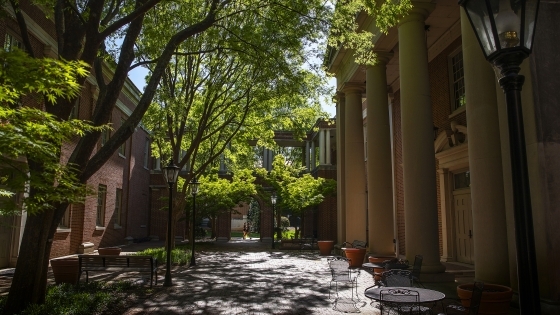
[326,0,560,314]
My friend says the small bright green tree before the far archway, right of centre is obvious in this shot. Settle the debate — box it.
[258,155,336,238]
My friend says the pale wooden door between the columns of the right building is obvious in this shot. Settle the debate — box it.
[453,191,474,264]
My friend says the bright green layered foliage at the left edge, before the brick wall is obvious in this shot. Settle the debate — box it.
[0,49,103,215]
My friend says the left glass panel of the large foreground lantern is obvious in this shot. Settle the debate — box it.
[464,0,497,57]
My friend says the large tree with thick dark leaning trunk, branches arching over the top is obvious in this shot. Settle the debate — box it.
[1,0,412,313]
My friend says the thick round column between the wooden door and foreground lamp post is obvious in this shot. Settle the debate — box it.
[461,8,509,285]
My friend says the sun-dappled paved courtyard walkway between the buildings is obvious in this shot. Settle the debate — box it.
[118,239,476,315]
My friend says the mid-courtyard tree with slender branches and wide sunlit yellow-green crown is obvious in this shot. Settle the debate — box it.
[139,1,332,248]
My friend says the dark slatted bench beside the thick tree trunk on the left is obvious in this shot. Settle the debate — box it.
[78,255,157,287]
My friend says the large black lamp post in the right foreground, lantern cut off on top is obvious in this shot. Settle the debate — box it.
[459,0,540,315]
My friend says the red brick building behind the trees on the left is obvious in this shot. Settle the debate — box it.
[0,2,152,268]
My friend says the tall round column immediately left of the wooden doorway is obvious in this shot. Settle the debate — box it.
[398,2,445,273]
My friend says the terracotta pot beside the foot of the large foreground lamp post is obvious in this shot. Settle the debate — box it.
[457,283,513,315]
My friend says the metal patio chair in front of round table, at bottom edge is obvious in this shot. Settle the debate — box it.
[379,288,431,315]
